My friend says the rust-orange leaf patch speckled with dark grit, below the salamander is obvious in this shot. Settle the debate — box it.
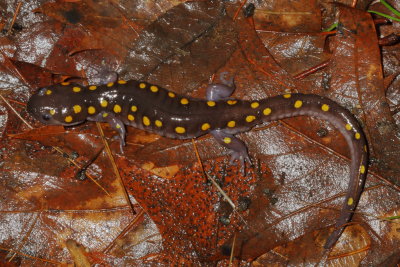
[118,157,255,257]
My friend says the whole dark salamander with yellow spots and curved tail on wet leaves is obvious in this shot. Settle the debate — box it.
[27,76,368,248]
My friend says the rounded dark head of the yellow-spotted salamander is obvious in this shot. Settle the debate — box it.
[27,86,88,126]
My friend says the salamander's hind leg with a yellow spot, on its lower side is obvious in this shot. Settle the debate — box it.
[210,130,251,175]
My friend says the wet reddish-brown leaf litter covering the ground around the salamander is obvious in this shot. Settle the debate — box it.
[0,0,400,266]
